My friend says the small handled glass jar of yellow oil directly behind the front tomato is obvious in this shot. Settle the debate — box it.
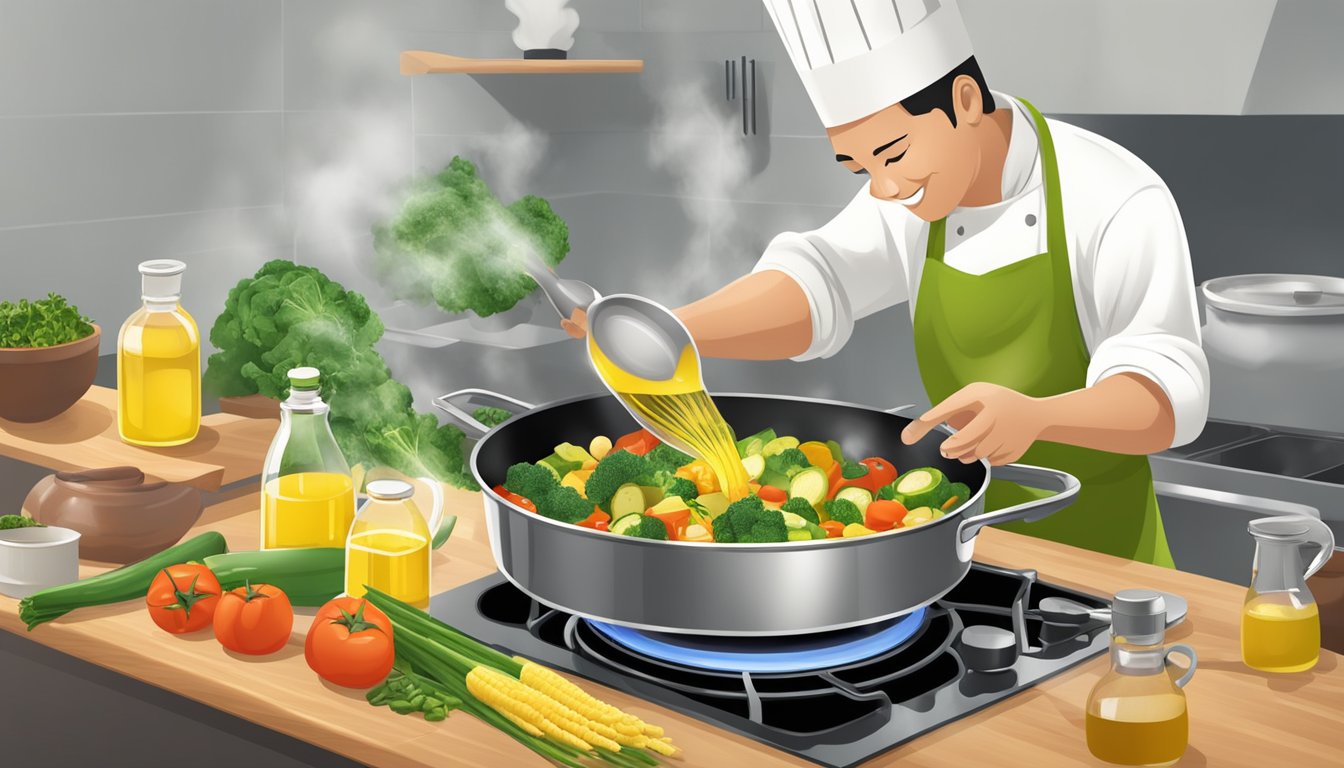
[345,477,444,608]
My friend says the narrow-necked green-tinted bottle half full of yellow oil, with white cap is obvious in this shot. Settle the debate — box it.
[261,367,355,549]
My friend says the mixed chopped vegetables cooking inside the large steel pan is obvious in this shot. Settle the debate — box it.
[495,429,970,543]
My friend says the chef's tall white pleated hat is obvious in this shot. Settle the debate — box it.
[765,0,972,128]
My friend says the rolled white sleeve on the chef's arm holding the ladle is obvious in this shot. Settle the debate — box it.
[751,188,907,360]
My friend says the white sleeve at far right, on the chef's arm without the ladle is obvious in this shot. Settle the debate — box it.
[1087,187,1208,447]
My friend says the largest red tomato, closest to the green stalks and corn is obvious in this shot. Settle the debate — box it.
[304,597,394,689]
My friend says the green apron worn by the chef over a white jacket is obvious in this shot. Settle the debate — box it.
[914,101,1175,568]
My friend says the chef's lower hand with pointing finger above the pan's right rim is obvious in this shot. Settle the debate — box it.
[900,382,1044,465]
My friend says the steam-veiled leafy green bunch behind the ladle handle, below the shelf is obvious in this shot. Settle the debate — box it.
[374,157,570,317]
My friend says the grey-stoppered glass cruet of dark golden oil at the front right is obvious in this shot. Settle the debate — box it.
[1087,589,1198,765]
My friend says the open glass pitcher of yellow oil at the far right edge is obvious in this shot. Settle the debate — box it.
[1242,515,1335,673]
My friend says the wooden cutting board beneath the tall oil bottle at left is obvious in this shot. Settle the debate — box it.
[0,386,280,491]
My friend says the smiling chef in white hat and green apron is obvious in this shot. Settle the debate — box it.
[564,0,1208,566]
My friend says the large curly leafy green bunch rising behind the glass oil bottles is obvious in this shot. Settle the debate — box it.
[202,260,476,488]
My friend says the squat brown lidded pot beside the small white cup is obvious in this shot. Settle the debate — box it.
[23,467,203,564]
